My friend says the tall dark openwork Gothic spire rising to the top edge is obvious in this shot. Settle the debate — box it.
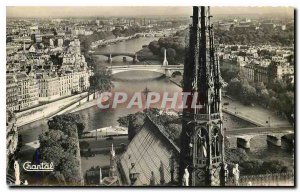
[179,7,225,186]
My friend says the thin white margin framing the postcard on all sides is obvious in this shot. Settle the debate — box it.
[0,0,300,191]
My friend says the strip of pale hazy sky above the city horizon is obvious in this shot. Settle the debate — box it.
[6,6,293,18]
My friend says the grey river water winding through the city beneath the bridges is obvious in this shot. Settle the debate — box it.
[20,37,293,169]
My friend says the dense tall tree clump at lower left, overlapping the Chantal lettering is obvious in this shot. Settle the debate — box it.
[34,114,85,185]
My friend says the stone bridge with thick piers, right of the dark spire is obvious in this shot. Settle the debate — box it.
[225,126,294,150]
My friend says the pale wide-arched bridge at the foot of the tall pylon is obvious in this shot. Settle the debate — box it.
[107,65,183,77]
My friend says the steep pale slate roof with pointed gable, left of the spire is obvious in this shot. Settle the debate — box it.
[118,117,179,186]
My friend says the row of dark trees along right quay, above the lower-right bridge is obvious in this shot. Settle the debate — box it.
[226,73,295,122]
